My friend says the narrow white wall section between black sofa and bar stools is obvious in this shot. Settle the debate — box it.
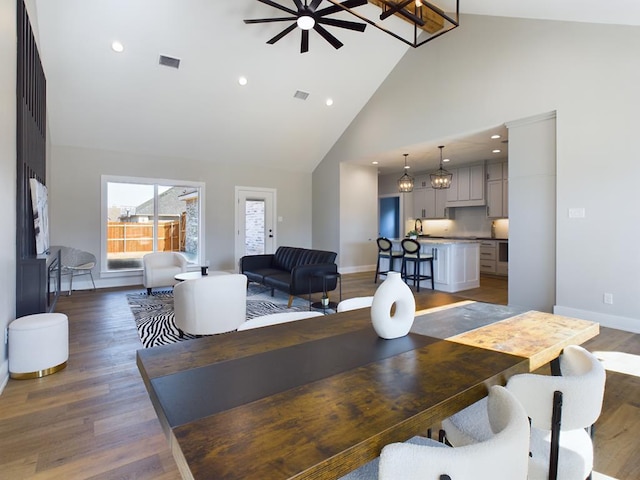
[339,163,378,273]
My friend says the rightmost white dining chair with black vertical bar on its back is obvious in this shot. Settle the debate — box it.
[442,345,606,480]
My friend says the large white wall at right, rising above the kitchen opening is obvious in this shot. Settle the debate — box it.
[314,16,640,330]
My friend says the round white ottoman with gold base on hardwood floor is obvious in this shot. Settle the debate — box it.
[9,313,69,380]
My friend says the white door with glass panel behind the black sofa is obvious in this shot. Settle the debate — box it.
[235,187,276,265]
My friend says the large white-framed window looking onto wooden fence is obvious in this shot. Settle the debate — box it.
[102,175,204,272]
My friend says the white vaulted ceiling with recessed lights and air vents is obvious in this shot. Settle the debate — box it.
[28,0,640,172]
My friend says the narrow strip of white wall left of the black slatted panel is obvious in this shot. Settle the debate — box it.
[0,0,17,392]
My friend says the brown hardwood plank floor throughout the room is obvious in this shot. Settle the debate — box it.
[0,272,640,480]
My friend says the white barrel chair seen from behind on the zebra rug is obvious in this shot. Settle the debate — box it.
[173,273,247,337]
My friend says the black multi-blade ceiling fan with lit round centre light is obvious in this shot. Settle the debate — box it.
[244,0,367,53]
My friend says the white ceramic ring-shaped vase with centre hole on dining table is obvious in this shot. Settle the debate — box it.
[371,272,416,340]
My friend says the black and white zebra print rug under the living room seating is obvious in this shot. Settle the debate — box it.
[127,283,320,348]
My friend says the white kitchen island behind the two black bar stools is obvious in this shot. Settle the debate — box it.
[388,237,480,293]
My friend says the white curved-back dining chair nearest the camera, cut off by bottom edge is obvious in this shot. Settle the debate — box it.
[341,385,529,480]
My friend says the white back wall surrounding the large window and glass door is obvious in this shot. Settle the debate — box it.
[49,147,311,288]
